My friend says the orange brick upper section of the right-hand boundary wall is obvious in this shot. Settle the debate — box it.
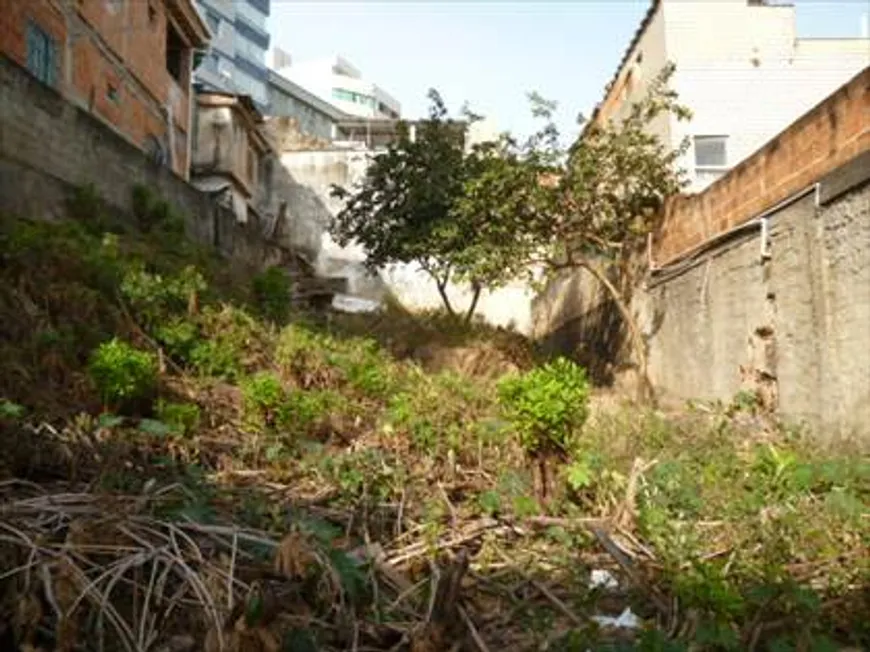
[653,68,870,265]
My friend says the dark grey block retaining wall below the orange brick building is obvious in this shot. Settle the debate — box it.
[0,55,282,266]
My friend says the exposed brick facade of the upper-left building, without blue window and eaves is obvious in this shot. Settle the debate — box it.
[0,0,190,177]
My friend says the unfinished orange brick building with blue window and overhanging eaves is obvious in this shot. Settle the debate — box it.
[0,0,210,178]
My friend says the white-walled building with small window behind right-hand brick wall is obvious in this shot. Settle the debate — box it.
[593,0,870,192]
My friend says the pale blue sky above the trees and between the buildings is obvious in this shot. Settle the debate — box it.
[270,0,868,140]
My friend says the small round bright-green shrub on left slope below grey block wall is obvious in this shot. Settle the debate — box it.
[88,338,157,405]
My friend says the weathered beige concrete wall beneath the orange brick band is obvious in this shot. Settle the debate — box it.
[638,157,870,439]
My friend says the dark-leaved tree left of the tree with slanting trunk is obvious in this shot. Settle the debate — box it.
[330,90,515,320]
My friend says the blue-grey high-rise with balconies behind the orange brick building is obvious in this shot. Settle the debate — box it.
[196,0,271,111]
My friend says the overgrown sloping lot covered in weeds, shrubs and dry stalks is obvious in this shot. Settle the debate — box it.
[0,182,870,652]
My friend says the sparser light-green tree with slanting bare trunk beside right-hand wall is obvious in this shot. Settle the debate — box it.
[454,66,689,394]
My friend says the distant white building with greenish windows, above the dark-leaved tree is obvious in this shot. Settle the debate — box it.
[274,55,402,120]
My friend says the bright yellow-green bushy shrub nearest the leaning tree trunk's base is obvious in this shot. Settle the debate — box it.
[498,358,589,456]
